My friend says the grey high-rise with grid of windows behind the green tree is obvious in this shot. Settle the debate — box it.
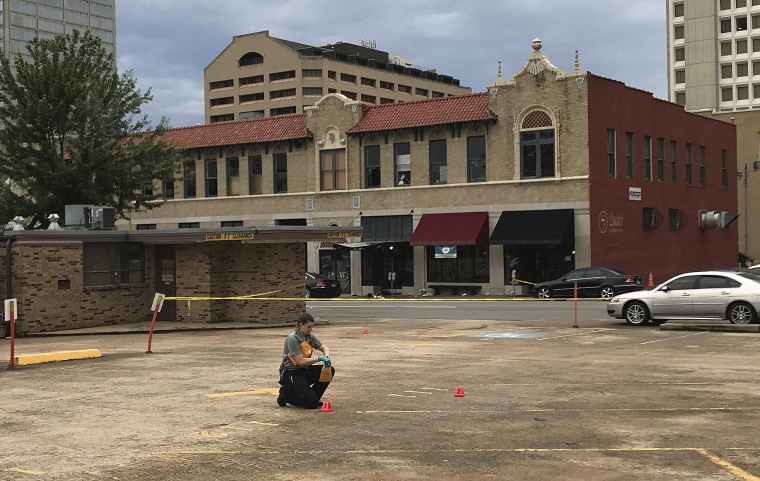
[0,0,116,61]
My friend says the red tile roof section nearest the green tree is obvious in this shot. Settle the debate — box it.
[162,114,312,149]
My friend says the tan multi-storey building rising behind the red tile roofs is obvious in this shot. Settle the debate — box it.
[203,31,471,123]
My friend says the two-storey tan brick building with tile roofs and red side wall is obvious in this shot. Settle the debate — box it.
[120,40,738,295]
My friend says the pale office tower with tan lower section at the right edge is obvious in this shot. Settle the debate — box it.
[666,0,760,262]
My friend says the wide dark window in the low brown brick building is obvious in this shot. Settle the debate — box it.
[82,242,145,287]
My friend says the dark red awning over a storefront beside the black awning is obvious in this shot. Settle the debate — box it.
[409,212,488,246]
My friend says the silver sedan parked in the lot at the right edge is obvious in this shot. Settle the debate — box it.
[607,270,760,326]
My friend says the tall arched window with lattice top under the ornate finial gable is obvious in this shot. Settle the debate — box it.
[520,110,556,179]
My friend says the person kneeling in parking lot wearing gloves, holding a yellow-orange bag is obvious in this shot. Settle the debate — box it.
[277,312,335,409]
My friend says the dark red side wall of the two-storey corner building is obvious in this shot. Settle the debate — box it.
[588,75,738,284]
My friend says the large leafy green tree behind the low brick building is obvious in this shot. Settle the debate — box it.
[0,31,178,227]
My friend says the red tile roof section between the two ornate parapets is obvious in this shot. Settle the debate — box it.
[348,93,496,134]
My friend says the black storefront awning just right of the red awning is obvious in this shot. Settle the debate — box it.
[491,209,575,245]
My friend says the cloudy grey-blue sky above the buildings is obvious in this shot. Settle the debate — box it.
[116,0,667,127]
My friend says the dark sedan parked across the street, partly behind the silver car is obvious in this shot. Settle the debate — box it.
[533,267,644,300]
